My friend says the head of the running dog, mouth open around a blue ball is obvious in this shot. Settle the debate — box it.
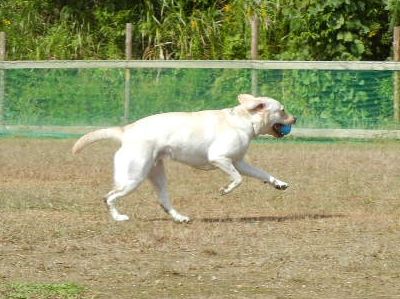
[238,94,296,138]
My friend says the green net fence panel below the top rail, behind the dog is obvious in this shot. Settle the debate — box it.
[0,62,400,138]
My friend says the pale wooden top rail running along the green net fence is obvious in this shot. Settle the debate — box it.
[0,60,400,71]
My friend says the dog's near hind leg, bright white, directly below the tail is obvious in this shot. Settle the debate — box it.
[105,150,150,221]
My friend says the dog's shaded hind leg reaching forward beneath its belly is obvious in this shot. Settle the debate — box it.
[149,160,190,223]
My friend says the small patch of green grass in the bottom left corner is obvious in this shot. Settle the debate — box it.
[0,283,85,299]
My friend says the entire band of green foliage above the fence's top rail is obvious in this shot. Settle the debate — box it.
[0,0,400,60]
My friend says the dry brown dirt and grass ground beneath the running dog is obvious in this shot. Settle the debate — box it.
[0,138,400,298]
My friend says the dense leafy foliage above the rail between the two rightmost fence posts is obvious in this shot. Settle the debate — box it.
[256,0,390,60]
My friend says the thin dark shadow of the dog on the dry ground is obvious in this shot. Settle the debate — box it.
[142,213,345,223]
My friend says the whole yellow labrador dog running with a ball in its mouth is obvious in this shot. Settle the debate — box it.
[72,94,296,222]
